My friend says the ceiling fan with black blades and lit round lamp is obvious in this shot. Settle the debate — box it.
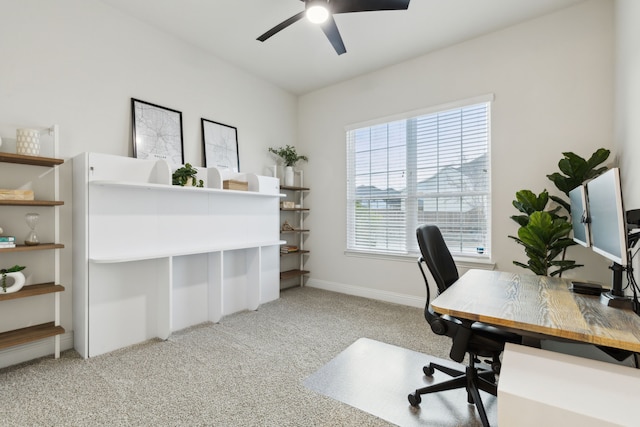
[257,0,410,55]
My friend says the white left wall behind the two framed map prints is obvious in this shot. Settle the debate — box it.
[0,0,297,365]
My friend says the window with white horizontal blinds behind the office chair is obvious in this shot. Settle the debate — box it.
[347,97,491,258]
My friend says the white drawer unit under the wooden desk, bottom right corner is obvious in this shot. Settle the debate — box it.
[498,344,640,427]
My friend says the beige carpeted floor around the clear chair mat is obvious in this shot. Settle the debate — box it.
[0,288,482,426]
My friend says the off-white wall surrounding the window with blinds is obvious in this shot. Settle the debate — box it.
[299,0,613,305]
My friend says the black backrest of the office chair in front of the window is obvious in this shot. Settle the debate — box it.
[416,224,460,293]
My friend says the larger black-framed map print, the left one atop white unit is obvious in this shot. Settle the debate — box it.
[131,98,184,165]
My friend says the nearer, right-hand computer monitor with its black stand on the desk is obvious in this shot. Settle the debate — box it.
[586,168,631,307]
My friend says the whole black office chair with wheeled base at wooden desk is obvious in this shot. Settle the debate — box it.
[409,225,522,426]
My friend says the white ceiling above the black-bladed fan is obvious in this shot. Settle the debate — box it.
[101,0,584,94]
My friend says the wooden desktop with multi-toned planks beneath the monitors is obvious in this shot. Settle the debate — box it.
[431,270,640,353]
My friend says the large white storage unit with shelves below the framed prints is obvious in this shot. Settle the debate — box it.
[73,153,282,357]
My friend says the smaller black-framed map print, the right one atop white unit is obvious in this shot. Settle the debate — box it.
[202,119,240,172]
